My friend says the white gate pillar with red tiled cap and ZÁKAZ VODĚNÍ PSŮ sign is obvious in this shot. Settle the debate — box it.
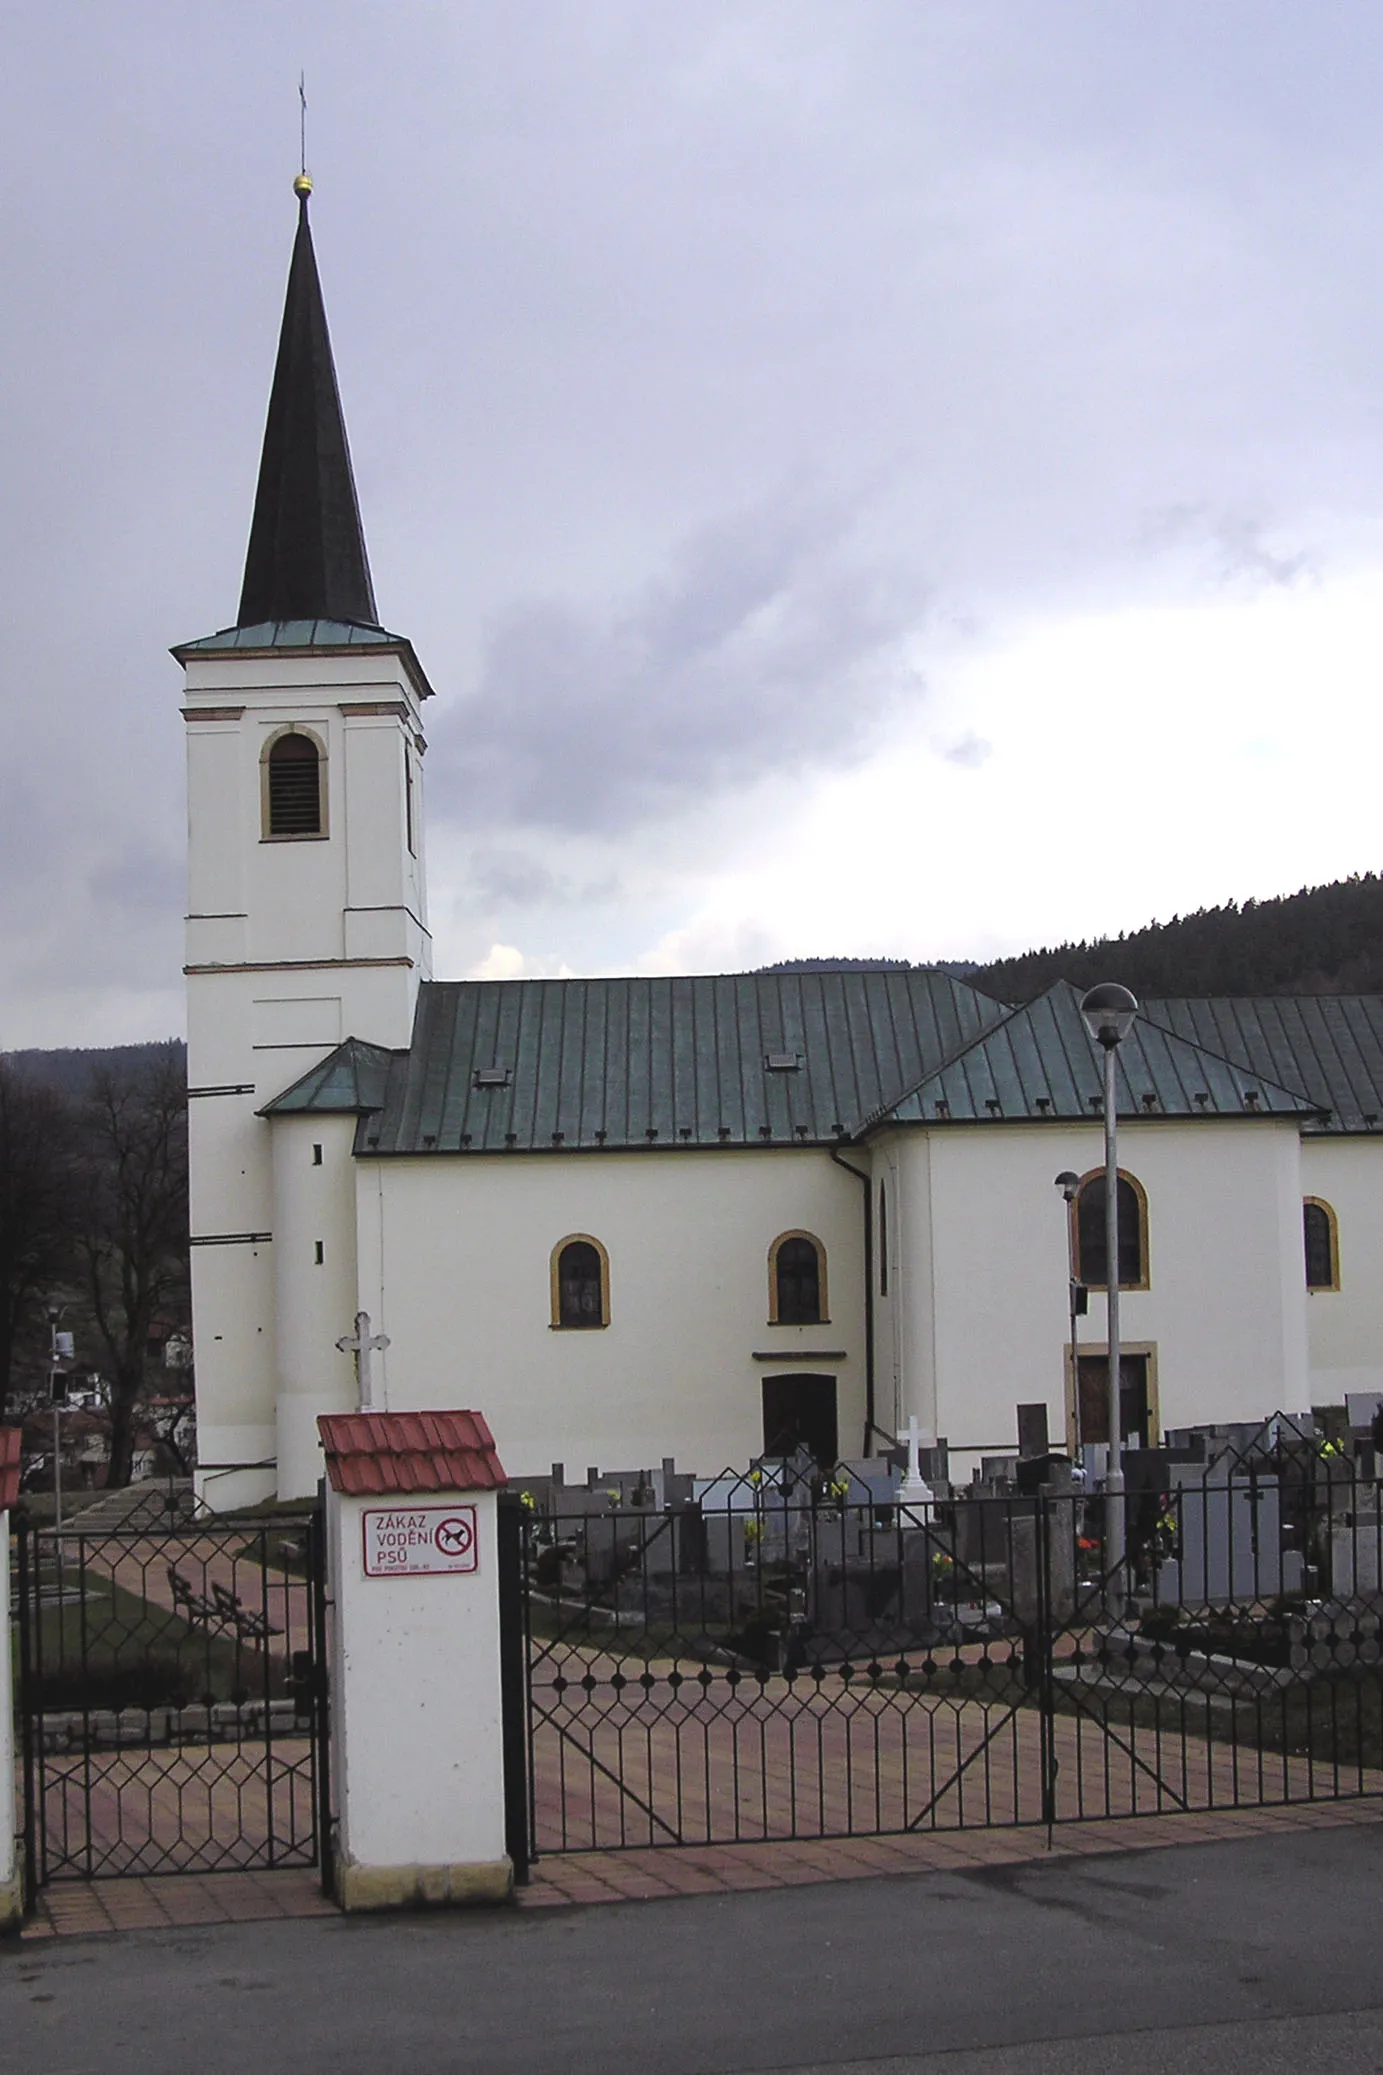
[317,1411,514,1909]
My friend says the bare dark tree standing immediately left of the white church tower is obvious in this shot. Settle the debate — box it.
[79,1044,189,1486]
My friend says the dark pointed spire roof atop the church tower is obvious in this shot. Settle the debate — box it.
[236,178,379,627]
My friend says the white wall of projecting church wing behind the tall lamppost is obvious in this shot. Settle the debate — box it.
[900,1121,1306,1461]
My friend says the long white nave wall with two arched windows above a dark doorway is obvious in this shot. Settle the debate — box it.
[335,1147,865,1477]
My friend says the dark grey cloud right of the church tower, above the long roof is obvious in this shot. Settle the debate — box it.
[431,496,923,834]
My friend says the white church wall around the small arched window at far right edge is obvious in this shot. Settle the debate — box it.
[1296,1137,1383,1405]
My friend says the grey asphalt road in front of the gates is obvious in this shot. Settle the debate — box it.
[0,1818,1383,2075]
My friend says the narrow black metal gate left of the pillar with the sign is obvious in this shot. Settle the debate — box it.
[15,1504,330,1907]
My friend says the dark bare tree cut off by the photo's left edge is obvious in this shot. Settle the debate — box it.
[0,1058,73,1419]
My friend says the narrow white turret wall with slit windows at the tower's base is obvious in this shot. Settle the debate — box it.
[270,1116,357,1498]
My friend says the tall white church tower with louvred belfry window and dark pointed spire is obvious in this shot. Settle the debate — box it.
[172,174,431,1509]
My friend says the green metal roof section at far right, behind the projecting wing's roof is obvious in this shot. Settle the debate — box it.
[1145,994,1383,1133]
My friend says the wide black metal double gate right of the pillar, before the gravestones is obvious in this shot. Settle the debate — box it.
[523,1438,1383,1855]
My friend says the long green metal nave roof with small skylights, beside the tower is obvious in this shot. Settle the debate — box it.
[356,969,1004,1154]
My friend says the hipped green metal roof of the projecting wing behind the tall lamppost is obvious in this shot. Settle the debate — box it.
[869,979,1315,1125]
